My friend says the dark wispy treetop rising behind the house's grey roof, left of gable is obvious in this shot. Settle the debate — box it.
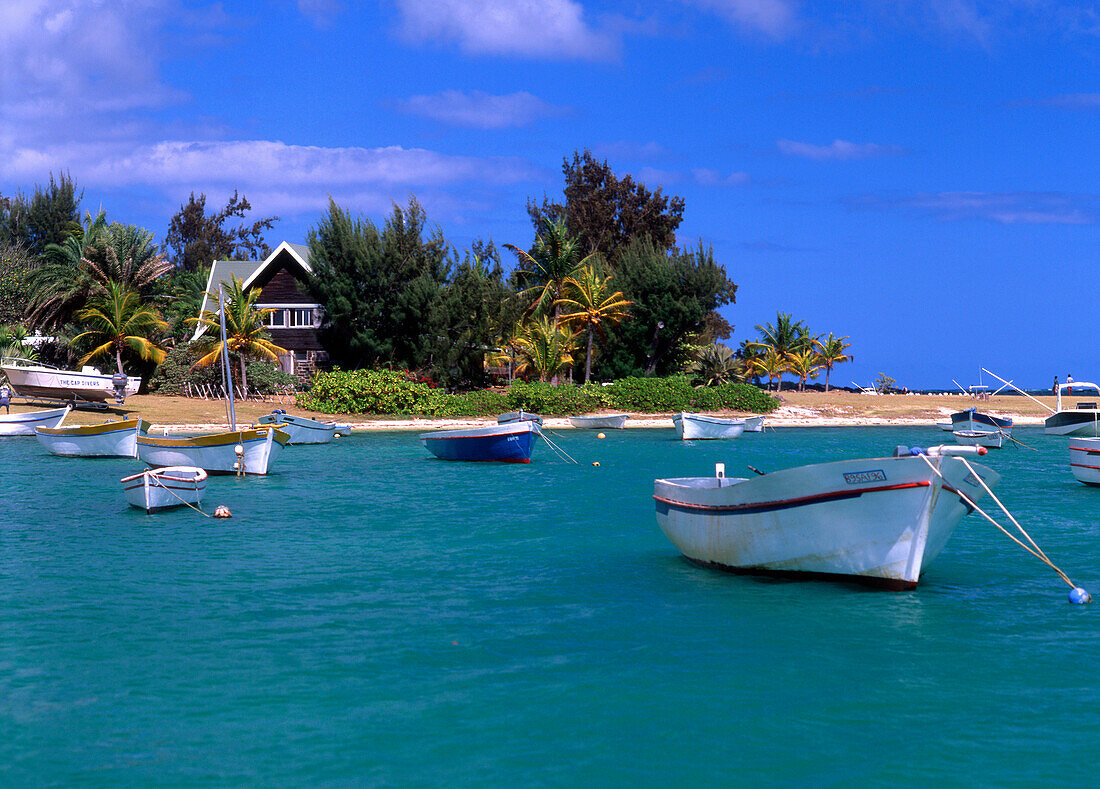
[165,189,278,272]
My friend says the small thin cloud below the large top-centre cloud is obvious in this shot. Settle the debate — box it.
[398,90,569,129]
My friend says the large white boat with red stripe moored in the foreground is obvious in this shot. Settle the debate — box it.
[653,446,1000,589]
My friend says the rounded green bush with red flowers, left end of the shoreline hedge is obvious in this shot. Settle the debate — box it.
[297,368,443,415]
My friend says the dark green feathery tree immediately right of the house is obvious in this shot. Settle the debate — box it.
[308,198,449,369]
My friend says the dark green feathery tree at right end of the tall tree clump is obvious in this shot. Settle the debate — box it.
[594,236,737,380]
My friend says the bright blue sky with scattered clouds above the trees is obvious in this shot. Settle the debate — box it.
[0,0,1100,387]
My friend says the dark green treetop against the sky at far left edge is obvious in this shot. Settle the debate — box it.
[0,173,84,256]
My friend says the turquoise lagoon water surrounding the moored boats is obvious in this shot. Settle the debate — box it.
[0,428,1100,787]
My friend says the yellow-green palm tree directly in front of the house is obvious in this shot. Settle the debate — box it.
[189,276,287,397]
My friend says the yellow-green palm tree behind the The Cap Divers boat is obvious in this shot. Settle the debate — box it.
[73,282,168,375]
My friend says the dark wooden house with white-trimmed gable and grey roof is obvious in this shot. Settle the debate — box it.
[191,241,329,383]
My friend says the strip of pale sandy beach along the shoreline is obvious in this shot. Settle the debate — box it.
[12,391,1064,432]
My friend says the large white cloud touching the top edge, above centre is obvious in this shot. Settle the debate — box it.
[396,0,618,61]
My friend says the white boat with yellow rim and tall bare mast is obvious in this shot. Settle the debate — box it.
[138,425,290,476]
